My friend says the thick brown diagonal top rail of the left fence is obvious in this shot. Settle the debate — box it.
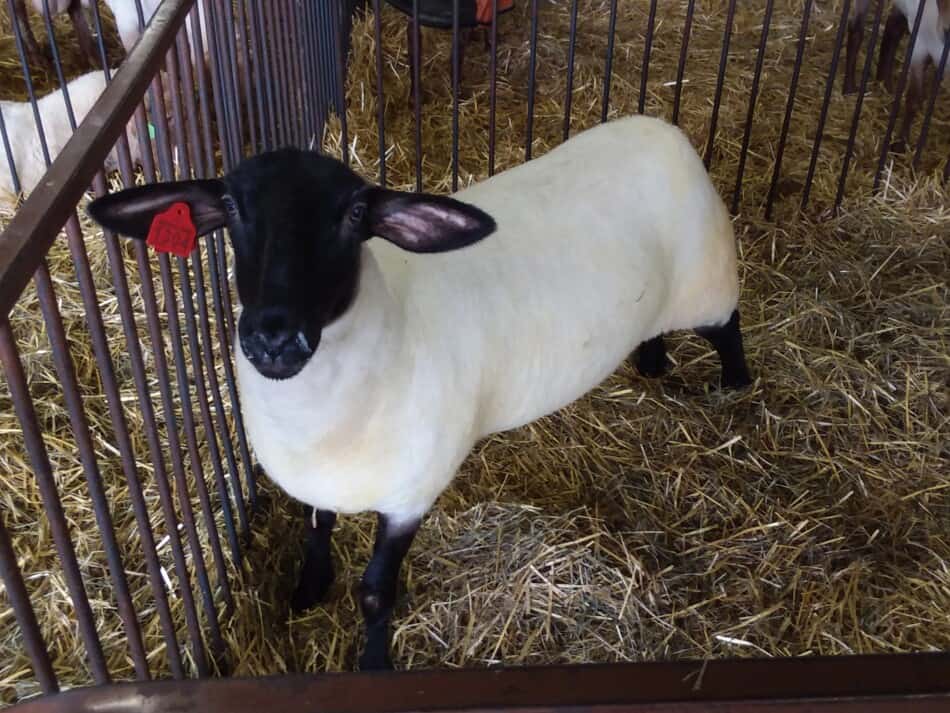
[0,0,193,314]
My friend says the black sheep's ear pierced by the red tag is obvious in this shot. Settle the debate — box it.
[86,178,227,240]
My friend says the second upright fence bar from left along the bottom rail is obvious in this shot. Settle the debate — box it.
[0,320,110,684]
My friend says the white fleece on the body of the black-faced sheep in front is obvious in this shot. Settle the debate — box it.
[235,116,739,526]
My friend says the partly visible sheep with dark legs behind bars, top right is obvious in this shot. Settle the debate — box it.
[843,0,950,152]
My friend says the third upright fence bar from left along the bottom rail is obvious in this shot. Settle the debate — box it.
[35,260,151,680]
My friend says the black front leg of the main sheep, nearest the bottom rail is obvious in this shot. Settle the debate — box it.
[360,515,419,671]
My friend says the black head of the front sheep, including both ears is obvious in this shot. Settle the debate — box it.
[88,144,495,379]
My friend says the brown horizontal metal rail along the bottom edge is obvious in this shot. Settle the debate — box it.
[7,653,950,713]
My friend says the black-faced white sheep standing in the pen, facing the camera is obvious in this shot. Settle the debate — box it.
[88,116,751,670]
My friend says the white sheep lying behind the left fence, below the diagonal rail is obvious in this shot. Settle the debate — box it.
[0,71,141,208]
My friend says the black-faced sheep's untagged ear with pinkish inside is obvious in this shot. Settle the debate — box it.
[367,188,497,253]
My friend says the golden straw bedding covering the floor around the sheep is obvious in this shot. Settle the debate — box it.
[0,0,950,702]
